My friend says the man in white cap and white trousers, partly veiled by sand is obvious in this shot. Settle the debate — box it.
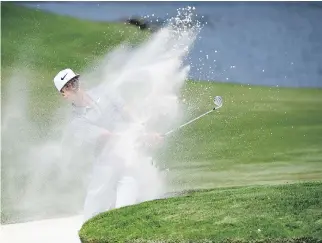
[54,68,162,221]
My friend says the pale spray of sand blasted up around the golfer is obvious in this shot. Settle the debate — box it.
[2,8,200,224]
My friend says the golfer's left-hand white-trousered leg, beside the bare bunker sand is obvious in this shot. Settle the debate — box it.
[84,165,119,221]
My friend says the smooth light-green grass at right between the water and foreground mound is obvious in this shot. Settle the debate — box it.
[157,82,322,192]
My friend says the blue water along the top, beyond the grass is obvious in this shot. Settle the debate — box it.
[21,2,322,87]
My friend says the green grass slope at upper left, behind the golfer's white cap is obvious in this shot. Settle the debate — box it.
[1,3,149,129]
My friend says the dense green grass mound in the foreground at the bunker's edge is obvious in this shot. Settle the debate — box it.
[79,183,322,243]
